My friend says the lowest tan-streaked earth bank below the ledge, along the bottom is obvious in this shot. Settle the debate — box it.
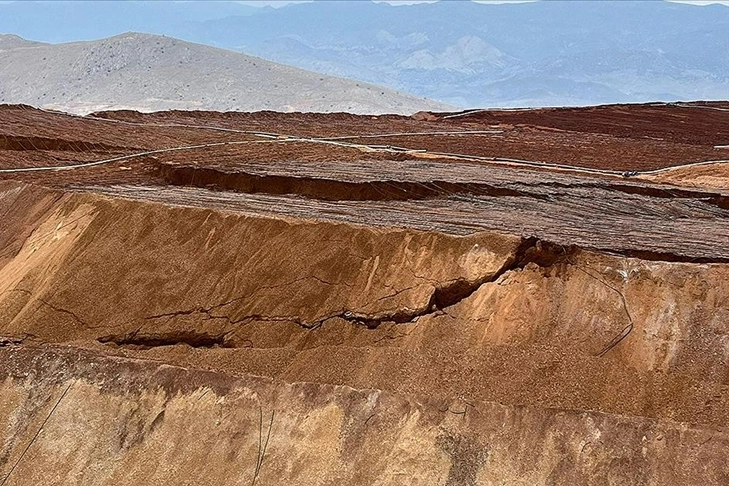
[0,346,729,485]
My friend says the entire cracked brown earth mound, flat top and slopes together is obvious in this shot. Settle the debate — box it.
[0,103,729,486]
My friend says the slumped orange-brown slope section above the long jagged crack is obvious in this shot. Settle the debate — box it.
[0,184,523,340]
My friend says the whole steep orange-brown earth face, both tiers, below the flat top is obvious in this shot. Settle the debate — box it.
[0,182,729,485]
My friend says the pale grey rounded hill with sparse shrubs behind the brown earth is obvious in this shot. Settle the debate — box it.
[0,33,449,114]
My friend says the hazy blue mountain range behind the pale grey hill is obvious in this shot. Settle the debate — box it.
[0,0,729,107]
